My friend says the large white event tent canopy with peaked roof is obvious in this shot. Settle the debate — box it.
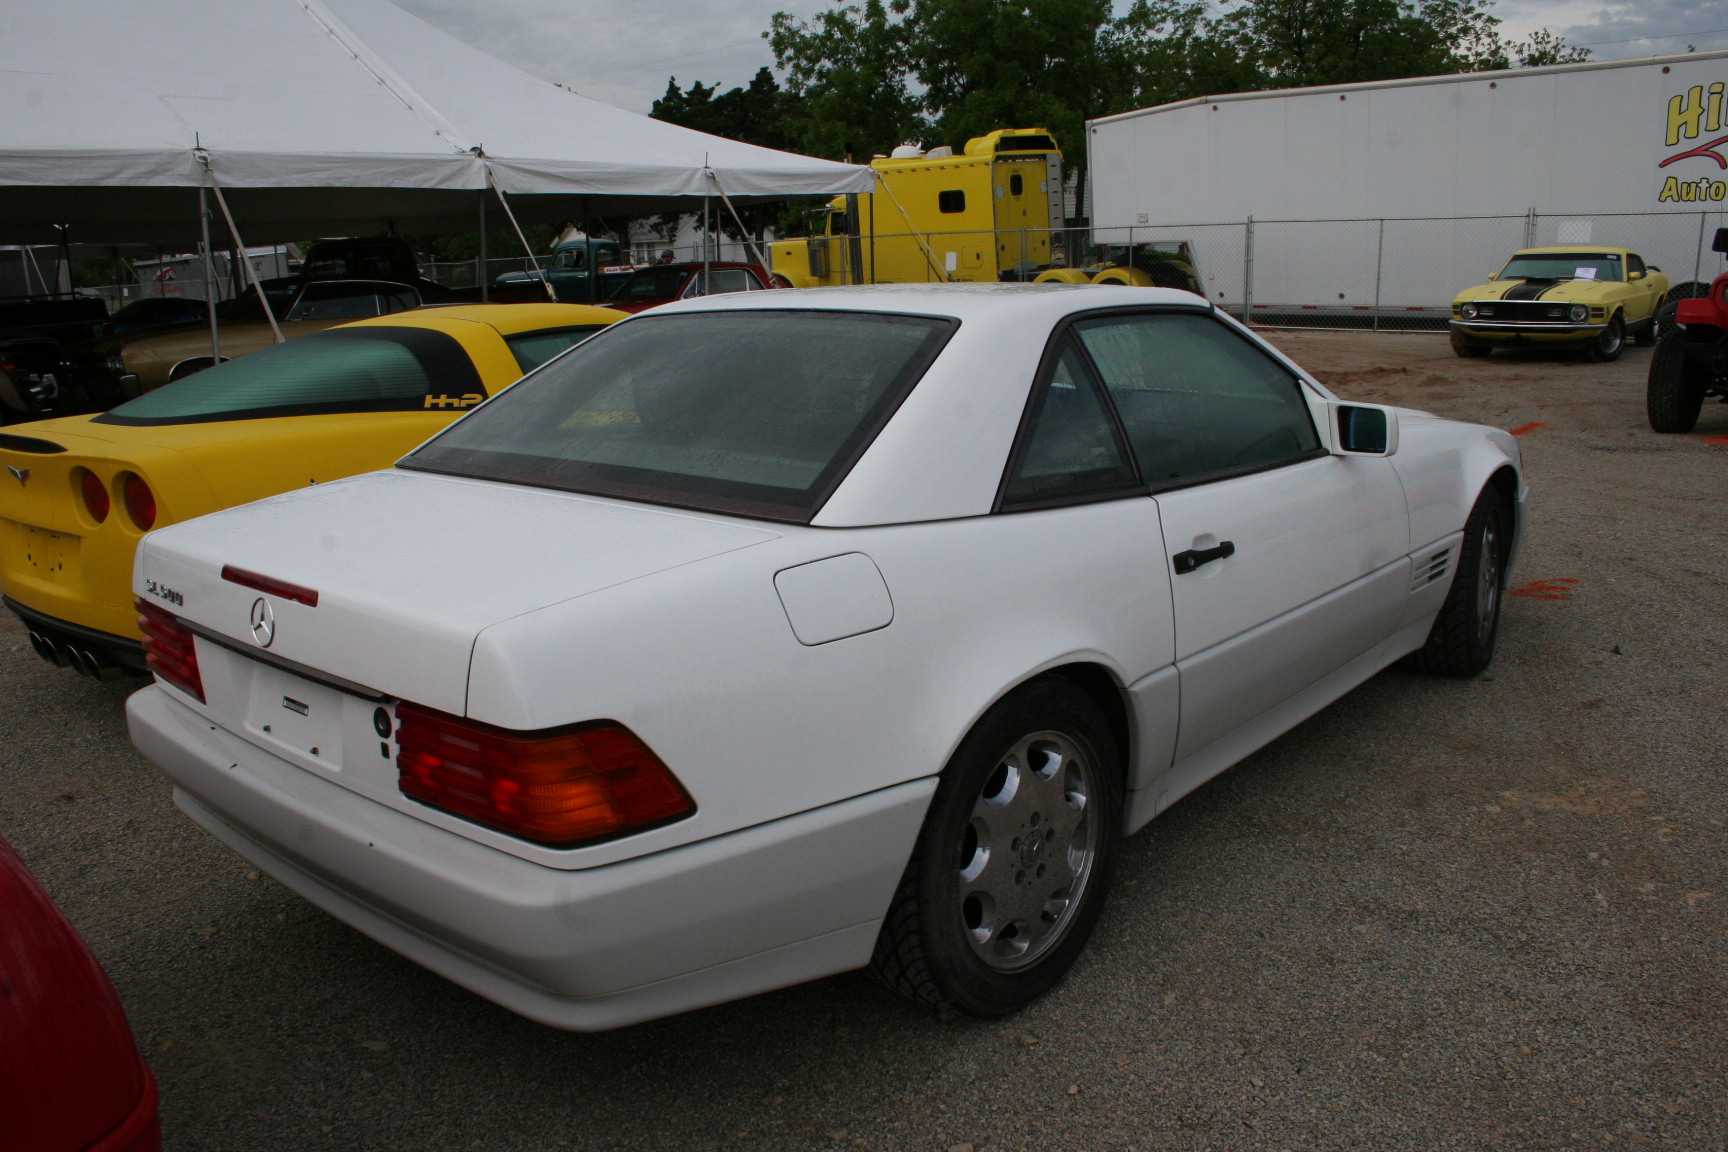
[0,0,873,244]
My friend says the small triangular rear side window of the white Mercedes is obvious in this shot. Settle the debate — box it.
[1002,337,1140,508]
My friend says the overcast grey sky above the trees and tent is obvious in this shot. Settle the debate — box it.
[396,0,1728,112]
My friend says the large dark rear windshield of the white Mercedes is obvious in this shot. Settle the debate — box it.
[399,311,956,522]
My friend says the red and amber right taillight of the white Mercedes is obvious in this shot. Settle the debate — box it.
[396,705,696,846]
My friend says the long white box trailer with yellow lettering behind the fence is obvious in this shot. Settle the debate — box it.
[1087,50,1728,326]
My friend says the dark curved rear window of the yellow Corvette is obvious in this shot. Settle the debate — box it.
[97,326,486,425]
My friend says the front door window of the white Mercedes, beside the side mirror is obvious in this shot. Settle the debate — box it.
[1075,313,1320,487]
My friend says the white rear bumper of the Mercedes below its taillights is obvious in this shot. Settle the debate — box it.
[126,686,935,1031]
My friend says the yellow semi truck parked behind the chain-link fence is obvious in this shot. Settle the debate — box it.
[771,128,1201,292]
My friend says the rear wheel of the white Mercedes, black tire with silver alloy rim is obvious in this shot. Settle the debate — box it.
[869,677,1121,1016]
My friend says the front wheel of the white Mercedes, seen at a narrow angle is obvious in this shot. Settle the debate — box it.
[1403,485,1512,675]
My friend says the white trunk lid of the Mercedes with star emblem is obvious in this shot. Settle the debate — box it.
[135,472,776,720]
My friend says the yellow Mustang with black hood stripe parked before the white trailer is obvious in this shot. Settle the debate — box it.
[1452,245,1668,361]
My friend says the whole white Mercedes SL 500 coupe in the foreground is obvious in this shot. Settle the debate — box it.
[128,285,1528,1029]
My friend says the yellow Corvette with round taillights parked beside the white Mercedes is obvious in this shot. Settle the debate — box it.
[0,304,626,677]
